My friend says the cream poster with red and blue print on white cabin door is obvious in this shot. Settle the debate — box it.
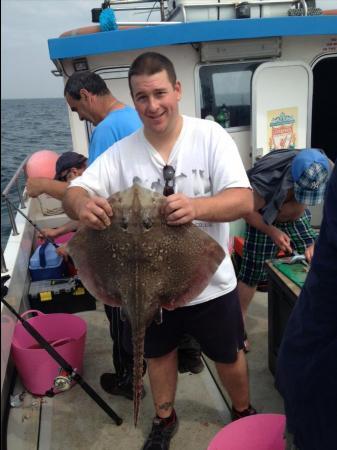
[267,107,298,150]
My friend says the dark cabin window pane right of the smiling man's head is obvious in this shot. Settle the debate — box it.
[199,63,258,128]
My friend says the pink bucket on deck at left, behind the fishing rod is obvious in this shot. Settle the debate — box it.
[12,310,87,395]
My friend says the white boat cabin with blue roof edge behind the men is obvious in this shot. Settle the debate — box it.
[48,0,337,225]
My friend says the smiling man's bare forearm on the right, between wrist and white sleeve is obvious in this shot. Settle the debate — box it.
[193,188,253,222]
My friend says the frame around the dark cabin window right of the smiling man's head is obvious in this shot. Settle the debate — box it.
[194,58,271,133]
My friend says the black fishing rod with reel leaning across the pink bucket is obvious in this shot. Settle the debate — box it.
[1,275,123,425]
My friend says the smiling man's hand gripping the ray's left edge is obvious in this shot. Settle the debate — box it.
[77,196,113,230]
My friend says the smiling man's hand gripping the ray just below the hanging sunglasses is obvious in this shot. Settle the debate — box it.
[163,193,197,225]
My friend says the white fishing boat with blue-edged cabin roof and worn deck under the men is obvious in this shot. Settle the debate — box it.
[1,0,337,450]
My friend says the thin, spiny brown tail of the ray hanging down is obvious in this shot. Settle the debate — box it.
[132,327,145,427]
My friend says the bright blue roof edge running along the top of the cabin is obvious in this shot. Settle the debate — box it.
[48,15,337,60]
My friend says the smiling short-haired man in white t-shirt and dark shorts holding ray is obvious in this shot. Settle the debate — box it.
[63,52,256,450]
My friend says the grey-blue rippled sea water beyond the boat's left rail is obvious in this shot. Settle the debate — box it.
[1,98,72,249]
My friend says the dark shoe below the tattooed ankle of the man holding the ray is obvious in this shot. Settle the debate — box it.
[142,413,178,450]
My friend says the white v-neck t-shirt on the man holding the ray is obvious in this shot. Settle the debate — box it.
[70,116,250,306]
